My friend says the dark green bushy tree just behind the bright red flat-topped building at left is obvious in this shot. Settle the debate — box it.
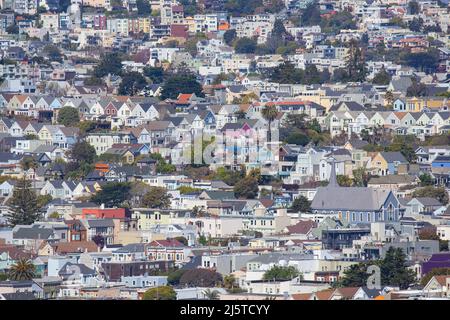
[91,182,131,208]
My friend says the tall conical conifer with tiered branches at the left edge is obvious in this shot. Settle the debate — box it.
[6,178,41,227]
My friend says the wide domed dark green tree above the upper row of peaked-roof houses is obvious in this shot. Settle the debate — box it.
[161,73,204,100]
